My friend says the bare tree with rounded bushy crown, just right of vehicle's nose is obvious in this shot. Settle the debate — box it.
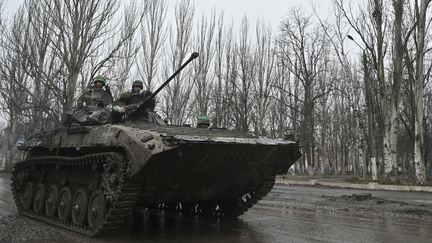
[280,9,329,173]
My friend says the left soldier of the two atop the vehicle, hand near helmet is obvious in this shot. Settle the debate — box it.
[77,76,113,108]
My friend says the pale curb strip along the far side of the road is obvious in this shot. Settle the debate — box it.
[276,179,432,193]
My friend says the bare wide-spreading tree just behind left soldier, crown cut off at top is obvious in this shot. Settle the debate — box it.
[40,0,142,110]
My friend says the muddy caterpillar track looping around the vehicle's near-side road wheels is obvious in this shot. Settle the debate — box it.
[11,152,141,236]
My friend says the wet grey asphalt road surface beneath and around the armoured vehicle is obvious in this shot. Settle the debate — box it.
[0,175,432,243]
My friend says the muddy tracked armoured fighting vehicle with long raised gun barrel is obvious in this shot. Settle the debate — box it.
[12,54,301,236]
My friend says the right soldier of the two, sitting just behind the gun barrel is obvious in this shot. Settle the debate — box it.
[112,80,156,122]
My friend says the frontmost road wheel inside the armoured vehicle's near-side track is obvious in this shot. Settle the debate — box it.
[87,190,106,230]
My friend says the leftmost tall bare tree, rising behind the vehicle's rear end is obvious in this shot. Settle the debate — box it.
[3,1,66,127]
